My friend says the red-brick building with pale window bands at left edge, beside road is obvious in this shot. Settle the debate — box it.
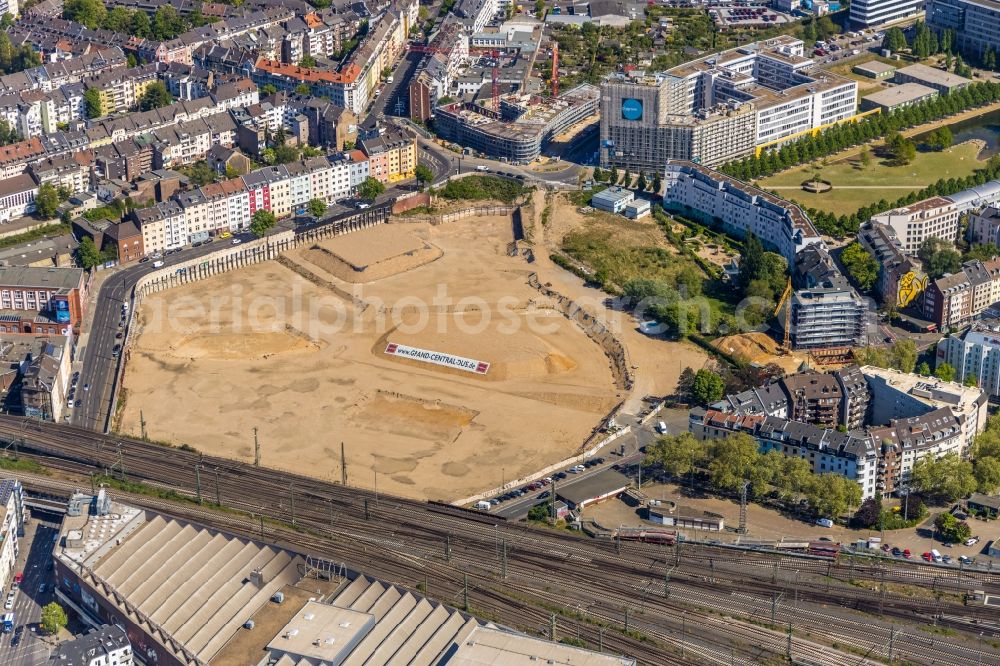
[0,266,87,335]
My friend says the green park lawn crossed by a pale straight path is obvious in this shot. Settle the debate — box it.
[757,143,984,215]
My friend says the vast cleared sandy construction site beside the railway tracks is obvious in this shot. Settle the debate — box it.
[121,218,620,499]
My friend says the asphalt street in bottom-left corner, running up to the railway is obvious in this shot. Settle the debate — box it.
[0,514,59,666]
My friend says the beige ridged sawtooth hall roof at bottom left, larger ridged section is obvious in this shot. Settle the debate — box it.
[56,495,302,663]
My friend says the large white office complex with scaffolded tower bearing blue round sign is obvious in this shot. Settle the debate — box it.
[600,37,857,170]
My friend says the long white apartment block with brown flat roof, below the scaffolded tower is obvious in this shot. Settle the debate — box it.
[663,161,822,265]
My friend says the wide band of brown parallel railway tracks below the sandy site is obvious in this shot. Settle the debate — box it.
[0,417,1000,666]
